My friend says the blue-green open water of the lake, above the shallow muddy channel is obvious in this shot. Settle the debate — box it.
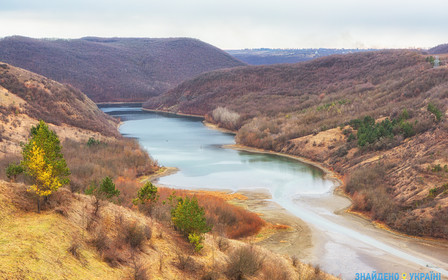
[103,108,332,196]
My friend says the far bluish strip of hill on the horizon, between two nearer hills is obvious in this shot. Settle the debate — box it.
[227,48,372,65]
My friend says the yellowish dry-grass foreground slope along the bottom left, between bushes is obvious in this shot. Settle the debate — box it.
[0,181,335,279]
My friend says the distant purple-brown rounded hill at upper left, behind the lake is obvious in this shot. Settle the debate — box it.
[0,36,244,102]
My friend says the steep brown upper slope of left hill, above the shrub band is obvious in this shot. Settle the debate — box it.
[0,64,118,136]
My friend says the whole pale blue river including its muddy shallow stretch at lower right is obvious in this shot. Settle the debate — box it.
[102,106,448,279]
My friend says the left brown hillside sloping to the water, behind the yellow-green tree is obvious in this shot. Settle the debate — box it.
[0,60,158,191]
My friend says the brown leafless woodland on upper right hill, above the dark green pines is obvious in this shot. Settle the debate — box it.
[144,51,447,117]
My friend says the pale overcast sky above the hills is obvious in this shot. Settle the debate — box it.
[0,0,448,49]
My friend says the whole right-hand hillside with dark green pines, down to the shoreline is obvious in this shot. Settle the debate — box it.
[144,50,448,239]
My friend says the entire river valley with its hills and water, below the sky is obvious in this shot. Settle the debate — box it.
[0,37,448,279]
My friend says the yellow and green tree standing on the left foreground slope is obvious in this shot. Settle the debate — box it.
[21,121,70,213]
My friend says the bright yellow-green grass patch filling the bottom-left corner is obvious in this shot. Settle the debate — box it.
[0,182,124,279]
